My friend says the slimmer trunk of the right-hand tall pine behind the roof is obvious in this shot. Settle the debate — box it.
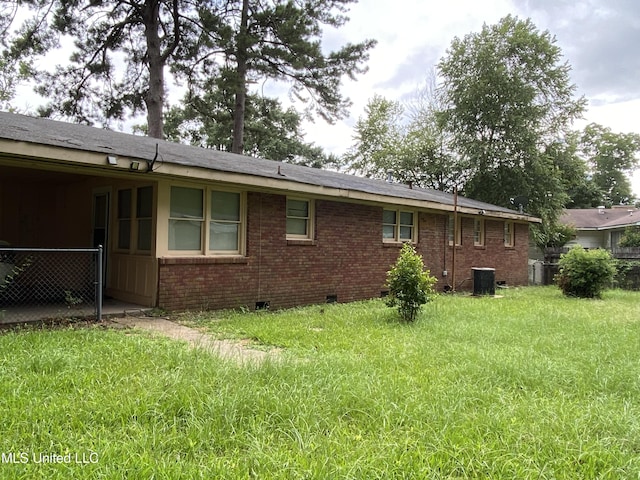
[231,0,249,154]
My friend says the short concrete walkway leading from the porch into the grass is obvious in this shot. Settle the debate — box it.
[111,317,278,363]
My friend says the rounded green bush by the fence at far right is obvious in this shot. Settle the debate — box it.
[555,245,616,298]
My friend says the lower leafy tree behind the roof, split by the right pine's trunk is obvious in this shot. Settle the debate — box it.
[165,70,337,168]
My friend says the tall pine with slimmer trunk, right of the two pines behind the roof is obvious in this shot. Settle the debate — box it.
[208,0,376,153]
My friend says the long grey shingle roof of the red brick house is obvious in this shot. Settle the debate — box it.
[0,112,539,222]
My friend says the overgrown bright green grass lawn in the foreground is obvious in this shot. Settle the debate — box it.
[0,287,640,479]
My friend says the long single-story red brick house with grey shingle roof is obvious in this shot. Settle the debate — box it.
[0,113,539,310]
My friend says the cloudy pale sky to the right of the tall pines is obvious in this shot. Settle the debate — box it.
[282,0,640,197]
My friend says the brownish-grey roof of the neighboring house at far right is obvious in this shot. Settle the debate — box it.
[560,206,640,230]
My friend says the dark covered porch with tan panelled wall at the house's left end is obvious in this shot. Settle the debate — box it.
[0,156,157,308]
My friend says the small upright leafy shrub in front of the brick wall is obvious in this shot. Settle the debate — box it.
[387,243,438,322]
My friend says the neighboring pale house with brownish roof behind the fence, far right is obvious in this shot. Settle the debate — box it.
[560,205,640,250]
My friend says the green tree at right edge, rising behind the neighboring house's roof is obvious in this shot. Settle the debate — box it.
[580,123,640,206]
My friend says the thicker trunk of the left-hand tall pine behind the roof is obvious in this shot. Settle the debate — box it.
[144,0,164,138]
